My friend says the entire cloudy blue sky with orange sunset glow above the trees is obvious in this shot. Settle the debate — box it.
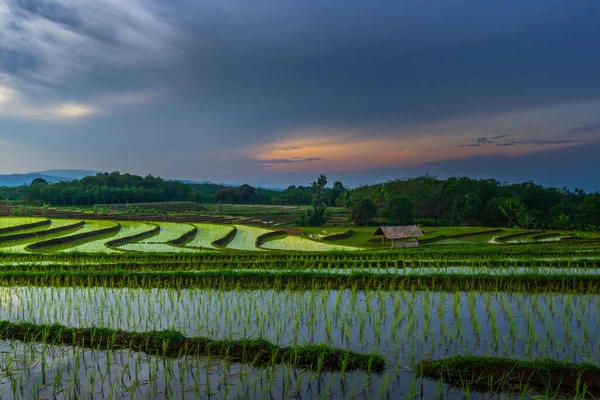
[0,0,600,191]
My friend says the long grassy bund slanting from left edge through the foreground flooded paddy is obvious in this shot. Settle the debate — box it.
[0,321,385,372]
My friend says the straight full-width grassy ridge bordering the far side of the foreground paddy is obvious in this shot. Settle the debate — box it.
[0,270,600,293]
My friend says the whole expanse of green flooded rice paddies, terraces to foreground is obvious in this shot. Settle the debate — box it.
[0,217,600,400]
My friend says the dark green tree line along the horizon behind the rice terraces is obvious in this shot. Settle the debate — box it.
[0,172,600,230]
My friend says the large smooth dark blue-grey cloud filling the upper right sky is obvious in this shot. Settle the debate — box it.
[170,1,600,136]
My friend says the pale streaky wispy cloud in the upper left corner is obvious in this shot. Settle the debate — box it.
[0,0,178,120]
